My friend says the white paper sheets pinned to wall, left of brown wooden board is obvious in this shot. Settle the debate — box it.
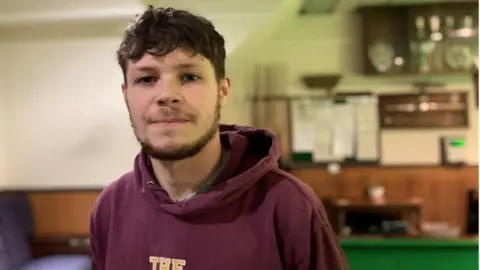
[292,97,379,162]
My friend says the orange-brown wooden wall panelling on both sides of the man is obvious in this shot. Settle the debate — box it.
[2,167,478,237]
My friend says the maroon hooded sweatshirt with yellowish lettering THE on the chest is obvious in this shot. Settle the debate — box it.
[90,125,348,270]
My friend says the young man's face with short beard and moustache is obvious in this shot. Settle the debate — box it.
[122,49,230,160]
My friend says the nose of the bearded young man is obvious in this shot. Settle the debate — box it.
[155,76,183,106]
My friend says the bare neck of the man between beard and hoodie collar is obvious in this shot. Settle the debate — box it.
[150,133,222,201]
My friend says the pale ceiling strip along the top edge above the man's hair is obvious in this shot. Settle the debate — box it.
[0,0,282,27]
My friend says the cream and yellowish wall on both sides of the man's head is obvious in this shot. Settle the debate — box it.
[0,0,478,188]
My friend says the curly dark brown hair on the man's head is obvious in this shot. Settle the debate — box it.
[117,5,226,80]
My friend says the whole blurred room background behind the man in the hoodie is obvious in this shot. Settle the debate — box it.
[0,0,478,270]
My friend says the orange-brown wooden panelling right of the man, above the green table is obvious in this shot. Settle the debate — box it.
[290,166,478,232]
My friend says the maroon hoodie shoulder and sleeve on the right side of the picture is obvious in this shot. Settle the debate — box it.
[267,170,348,270]
